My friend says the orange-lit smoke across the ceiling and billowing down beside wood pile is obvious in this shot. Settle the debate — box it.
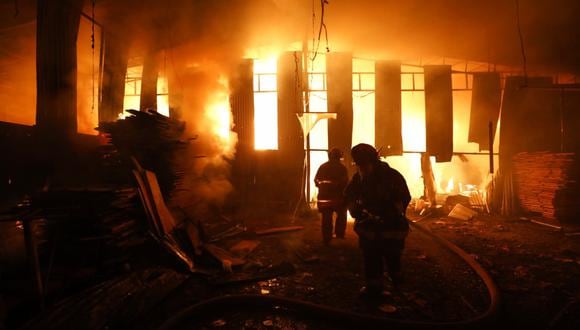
[0,0,580,214]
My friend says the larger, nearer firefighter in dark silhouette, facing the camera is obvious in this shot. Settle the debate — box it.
[345,143,411,297]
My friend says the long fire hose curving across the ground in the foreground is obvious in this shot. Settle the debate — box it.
[160,222,501,330]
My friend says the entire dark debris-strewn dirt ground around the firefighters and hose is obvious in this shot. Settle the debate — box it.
[4,209,580,329]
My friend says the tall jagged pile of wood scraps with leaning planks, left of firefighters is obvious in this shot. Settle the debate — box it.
[99,110,303,273]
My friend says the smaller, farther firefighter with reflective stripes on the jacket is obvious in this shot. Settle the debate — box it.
[314,148,348,245]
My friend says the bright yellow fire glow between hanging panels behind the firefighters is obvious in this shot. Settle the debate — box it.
[247,55,497,201]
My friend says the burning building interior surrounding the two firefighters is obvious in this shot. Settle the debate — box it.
[0,0,580,328]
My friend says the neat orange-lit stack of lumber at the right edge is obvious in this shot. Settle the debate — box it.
[513,152,580,222]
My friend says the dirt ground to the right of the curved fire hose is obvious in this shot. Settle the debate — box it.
[422,216,580,329]
